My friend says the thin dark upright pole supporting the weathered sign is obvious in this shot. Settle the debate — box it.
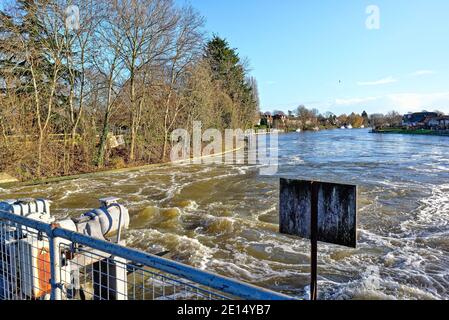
[310,182,319,301]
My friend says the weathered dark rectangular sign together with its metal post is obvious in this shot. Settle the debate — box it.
[279,179,357,300]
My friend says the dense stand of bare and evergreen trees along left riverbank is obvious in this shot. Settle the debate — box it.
[0,0,259,179]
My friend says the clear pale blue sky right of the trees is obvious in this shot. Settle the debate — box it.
[177,0,449,113]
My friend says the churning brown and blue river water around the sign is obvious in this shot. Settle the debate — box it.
[0,130,449,299]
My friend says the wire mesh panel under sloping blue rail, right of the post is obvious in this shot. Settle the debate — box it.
[60,245,232,300]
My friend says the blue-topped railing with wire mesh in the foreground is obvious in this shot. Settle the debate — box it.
[0,211,289,300]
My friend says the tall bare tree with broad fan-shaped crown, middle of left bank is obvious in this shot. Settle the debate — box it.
[112,0,178,161]
